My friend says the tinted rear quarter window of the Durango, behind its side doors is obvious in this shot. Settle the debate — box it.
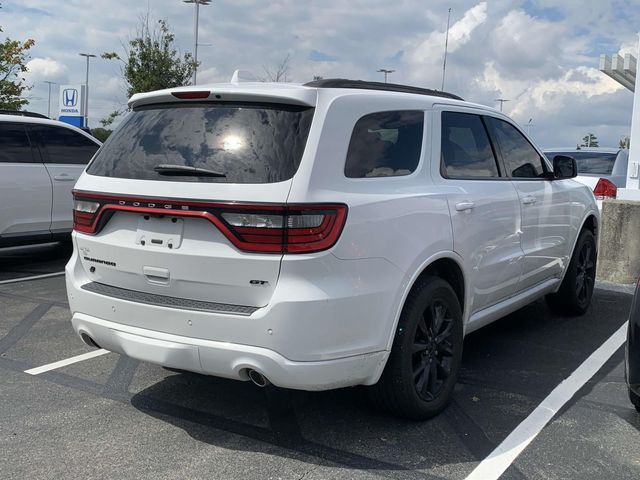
[344,110,424,178]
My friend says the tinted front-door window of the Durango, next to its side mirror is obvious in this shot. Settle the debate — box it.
[487,117,545,178]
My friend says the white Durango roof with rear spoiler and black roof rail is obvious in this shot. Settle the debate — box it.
[129,79,499,113]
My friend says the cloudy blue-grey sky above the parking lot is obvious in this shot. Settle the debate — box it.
[0,0,640,148]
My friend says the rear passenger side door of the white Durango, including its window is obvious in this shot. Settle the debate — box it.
[435,110,523,315]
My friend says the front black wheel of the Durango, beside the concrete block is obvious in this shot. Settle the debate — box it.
[546,230,597,316]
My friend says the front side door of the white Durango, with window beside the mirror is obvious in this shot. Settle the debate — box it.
[486,117,575,291]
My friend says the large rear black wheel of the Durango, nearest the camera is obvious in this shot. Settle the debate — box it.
[369,277,463,420]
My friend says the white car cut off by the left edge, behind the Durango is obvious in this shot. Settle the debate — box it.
[0,111,100,247]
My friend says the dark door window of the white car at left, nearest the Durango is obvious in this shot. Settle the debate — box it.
[30,125,98,164]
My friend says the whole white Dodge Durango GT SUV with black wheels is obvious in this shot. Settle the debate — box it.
[66,80,598,418]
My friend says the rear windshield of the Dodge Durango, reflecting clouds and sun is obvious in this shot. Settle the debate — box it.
[87,103,313,183]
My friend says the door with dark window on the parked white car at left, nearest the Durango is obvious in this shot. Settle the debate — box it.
[29,124,100,233]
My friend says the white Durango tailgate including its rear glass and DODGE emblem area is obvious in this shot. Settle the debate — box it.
[76,102,313,307]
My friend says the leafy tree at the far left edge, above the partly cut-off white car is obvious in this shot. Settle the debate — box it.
[0,21,35,110]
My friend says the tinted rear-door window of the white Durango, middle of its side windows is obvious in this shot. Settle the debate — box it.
[440,112,500,178]
